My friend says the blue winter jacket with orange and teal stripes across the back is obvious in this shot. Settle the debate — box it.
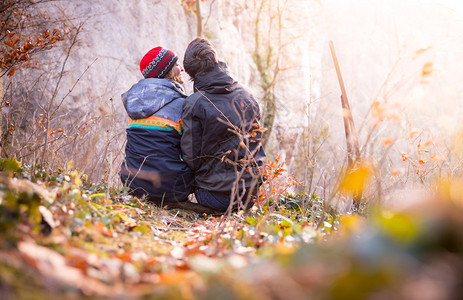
[121,78,194,202]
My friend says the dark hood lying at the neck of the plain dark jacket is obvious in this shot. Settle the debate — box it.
[194,62,237,94]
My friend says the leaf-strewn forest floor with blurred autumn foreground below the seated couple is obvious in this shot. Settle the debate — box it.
[0,161,463,299]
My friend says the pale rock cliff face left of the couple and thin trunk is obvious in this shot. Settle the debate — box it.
[40,0,196,182]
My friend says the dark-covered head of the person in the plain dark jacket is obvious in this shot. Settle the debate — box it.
[183,37,219,80]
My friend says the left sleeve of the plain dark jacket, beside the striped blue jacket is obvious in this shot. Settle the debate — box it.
[180,94,202,171]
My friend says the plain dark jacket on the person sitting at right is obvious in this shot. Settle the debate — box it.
[181,62,265,193]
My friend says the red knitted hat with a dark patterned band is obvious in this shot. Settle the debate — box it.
[140,47,178,78]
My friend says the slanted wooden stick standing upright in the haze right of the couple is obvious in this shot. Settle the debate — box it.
[329,41,360,166]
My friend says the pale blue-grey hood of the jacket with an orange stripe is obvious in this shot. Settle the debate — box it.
[125,78,186,119]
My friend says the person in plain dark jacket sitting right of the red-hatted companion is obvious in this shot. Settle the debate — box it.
[181,38,265,211]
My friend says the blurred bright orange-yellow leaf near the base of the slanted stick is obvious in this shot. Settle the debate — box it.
[339,163,372,195]
